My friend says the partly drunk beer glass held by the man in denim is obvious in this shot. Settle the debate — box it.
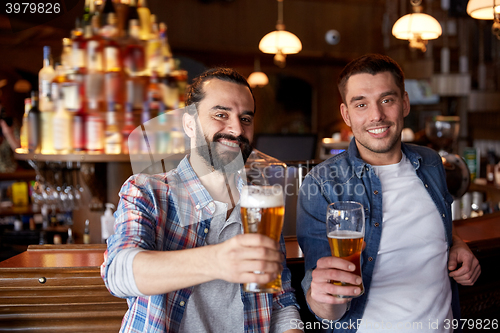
[326,201,365,298]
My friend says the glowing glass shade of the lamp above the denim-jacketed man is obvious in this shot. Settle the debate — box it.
[392,13,443,40]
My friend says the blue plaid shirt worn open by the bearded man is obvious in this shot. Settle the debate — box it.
[101,157,298,333]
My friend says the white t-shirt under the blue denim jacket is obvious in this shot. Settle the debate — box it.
[358,155,453,332]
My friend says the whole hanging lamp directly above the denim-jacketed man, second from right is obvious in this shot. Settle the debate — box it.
[392,0,443,52]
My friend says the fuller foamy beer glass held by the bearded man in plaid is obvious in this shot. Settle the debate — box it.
[240,185,285,293]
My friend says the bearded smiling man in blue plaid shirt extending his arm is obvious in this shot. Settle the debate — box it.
[101,68,300,333]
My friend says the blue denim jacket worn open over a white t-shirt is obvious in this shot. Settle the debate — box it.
[297,139,460,332]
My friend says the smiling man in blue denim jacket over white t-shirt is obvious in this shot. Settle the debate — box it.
[297,54,481,332]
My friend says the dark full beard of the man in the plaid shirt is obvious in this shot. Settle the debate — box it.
[196,128,252,173]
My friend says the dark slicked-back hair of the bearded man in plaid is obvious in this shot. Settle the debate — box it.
[186,67,255,114]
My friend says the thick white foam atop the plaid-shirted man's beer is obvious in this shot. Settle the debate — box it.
[240,186,284,208]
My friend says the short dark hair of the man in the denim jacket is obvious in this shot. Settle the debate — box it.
[337,53,405,103]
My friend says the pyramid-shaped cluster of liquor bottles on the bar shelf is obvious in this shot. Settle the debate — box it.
[21,0,187,154]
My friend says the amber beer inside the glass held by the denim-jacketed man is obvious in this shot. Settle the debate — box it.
[328,230,364,297]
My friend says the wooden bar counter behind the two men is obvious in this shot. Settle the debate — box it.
[0,212,500,332]
